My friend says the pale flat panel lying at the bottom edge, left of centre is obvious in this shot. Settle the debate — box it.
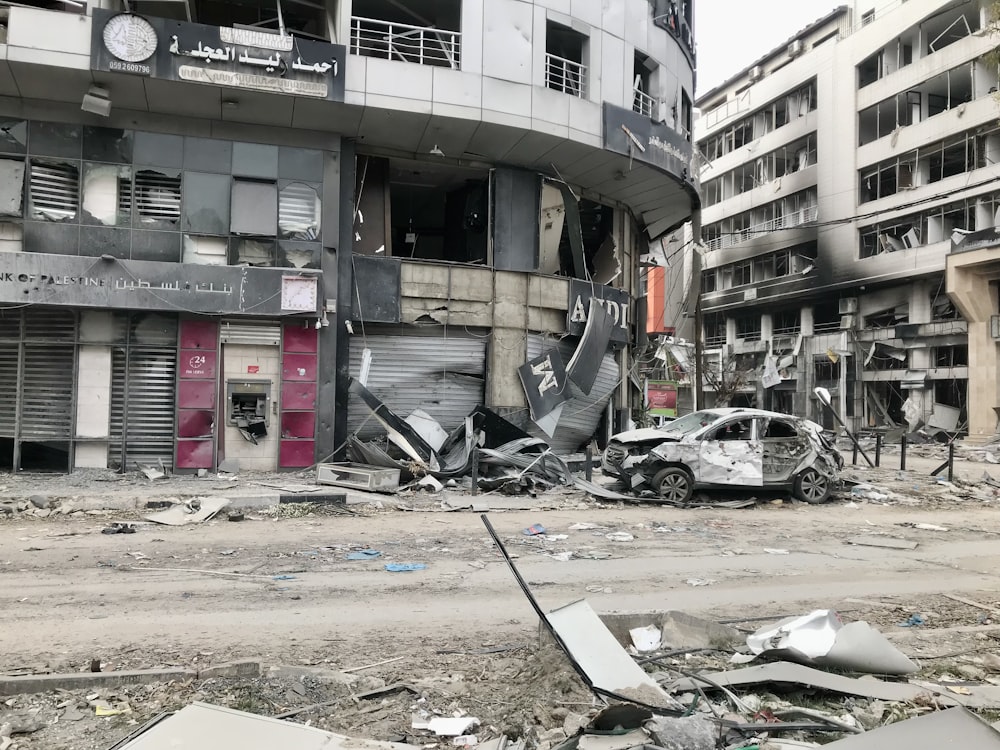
[112,702,412,750]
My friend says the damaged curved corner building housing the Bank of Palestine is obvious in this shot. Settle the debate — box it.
[0,0,698,471]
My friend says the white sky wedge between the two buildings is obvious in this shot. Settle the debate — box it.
[694,0,852,96]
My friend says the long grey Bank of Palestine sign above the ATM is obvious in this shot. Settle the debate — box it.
[0,253,320,316]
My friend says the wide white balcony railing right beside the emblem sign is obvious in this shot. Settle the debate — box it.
[351,16,462,70]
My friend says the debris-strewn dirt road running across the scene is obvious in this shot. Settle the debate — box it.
[0,496,1000,669]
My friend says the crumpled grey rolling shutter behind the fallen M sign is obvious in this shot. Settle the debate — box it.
[525,333,618,453]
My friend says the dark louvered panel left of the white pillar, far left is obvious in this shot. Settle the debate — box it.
[21,344,76,440]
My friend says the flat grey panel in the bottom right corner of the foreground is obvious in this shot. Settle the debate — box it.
[823,708,1000,750]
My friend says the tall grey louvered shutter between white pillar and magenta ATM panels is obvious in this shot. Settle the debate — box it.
[108,316,177,470]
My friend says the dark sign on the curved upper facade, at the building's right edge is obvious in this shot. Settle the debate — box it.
[604,102,692,180]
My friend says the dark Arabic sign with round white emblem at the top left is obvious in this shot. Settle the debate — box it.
[90,8,347,101]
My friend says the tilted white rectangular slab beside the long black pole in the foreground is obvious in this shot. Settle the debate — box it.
[547,599,678,708]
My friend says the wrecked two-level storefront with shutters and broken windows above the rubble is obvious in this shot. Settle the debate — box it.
[338,122,692,453]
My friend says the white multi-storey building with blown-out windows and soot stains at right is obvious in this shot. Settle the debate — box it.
[696,0,1000,440]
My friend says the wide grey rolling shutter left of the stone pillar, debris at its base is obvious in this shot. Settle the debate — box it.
[347,330,486,440]
